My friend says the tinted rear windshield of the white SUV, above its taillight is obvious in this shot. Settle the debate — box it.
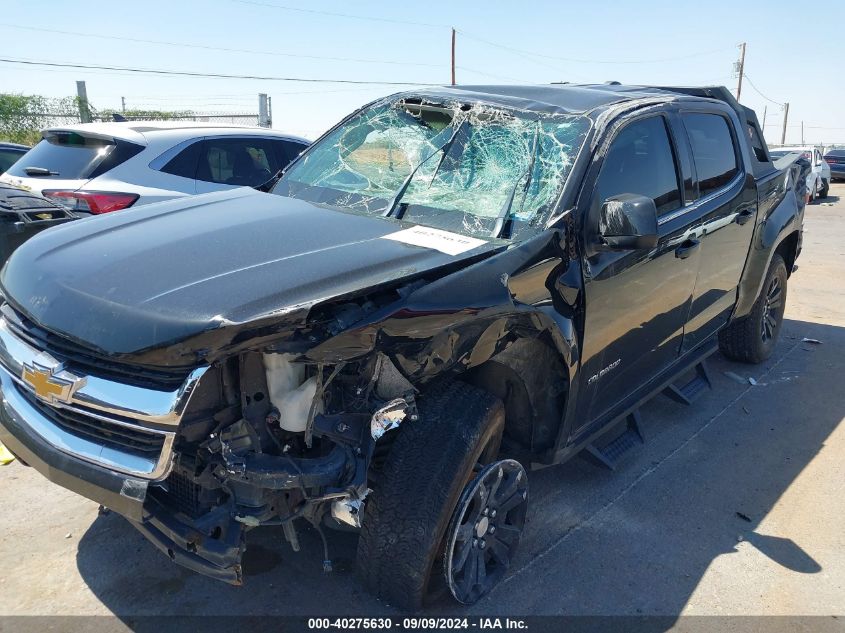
[9,131,143,180]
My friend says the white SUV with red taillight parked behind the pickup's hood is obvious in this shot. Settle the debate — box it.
[0,121,309,215]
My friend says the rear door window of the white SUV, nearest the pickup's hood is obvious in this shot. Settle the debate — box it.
[197,138,280,187]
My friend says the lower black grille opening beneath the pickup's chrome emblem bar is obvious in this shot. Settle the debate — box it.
[15,385,164,456]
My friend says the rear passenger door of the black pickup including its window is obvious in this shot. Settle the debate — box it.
[679,108,757,352]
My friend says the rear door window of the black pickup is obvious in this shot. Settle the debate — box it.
[683,113,739,197]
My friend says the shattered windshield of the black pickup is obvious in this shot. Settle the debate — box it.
[274,99,590,237]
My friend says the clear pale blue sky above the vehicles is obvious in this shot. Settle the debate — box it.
[0,0,845,143]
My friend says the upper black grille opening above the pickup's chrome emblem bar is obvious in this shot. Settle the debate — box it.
[0,303,190,391]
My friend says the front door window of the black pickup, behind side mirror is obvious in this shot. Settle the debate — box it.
[593,116,681,217]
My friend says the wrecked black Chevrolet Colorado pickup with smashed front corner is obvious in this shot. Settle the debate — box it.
[0,85,803,608]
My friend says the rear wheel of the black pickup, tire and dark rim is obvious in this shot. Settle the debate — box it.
[719,254,787,363]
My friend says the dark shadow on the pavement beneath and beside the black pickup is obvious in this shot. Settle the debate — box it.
[77,320,845,629]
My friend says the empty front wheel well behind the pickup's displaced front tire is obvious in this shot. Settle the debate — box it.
[461,339,569,457]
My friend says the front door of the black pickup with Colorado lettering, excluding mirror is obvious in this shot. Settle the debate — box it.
[573,114,700,435]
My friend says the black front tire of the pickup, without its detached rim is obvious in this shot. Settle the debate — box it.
[357,381,505,611]
